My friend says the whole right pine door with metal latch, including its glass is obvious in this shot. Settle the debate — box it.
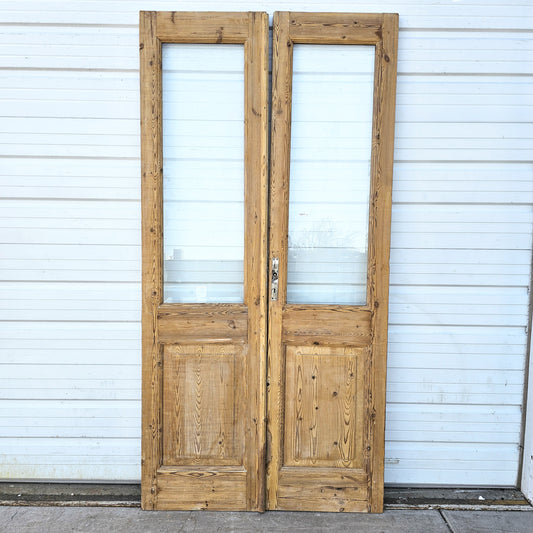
[267,12,398,512]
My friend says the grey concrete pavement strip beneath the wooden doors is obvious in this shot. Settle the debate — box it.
[0,506,533,533]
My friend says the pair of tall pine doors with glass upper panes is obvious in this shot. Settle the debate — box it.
[140,12,398,512]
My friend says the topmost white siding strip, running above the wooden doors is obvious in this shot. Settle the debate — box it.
[0,0,533,29]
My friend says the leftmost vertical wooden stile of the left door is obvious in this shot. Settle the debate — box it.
[139,11,163,509]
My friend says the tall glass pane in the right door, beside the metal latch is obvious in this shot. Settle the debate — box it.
[287,44,375,305]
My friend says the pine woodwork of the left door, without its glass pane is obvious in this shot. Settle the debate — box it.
[140,12,268,511]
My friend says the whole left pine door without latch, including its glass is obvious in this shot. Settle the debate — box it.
[140,12,268,511]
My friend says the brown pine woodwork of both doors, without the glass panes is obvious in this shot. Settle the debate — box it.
[140,12,398,512]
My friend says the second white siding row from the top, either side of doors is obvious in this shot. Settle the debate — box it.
[4,25,533,74]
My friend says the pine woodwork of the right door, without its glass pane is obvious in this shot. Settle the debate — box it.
[267,12,398,512]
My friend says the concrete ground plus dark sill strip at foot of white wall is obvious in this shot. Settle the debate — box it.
[0,482,533,533]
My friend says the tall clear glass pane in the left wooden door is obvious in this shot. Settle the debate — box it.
[163,44,244,303]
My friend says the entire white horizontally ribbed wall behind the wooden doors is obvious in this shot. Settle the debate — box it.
[0,0,533,485]
